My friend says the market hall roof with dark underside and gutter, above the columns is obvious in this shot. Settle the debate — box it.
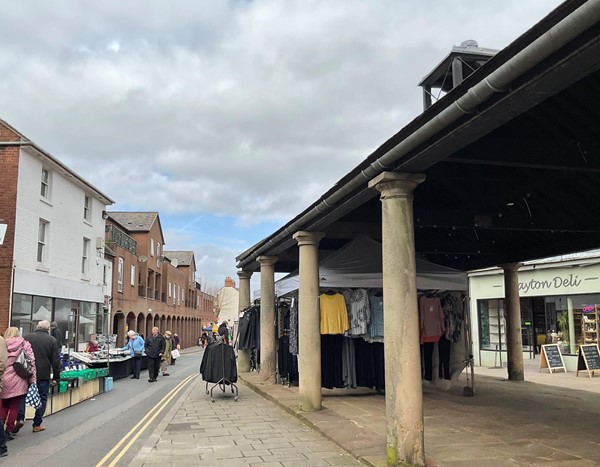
[237,0,600,272]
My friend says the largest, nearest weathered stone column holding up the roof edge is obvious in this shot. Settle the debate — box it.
[369,172,425,466]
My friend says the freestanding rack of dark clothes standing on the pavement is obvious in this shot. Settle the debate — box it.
[200,336,239,402]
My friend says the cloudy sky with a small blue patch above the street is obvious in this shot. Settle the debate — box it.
[0,0,561,290]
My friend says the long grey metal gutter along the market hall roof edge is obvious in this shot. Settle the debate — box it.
[236,0,600,269]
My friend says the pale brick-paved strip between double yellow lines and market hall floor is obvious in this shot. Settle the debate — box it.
[130,378,361,467]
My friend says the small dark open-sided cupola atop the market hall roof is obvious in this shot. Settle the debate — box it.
[419,40,498,110]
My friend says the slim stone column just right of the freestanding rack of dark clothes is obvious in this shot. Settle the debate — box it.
[256,256,277,383]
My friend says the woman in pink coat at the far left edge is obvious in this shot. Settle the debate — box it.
[0,327,36,440]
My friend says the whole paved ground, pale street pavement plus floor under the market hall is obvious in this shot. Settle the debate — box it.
[131,352,600,467]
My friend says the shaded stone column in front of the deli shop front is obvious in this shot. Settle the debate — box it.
[502,263,525,381]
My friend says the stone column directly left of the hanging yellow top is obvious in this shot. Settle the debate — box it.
[293,232,323,412]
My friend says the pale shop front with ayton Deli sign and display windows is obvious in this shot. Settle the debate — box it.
[469,253,600,371]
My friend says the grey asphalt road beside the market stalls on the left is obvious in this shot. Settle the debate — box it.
[0,352,201,467]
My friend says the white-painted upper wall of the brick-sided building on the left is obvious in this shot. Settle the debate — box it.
[13,148,106,303]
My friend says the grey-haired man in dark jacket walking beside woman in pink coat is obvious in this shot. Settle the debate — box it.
[13,320,60,433]
